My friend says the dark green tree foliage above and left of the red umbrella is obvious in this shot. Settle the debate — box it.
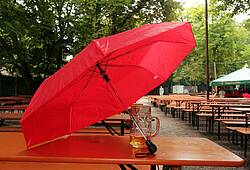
[0,0,180,92]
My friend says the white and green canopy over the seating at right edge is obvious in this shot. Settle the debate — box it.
[211,65,250,86]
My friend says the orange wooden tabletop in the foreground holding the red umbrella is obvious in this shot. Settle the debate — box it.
[0,132,245,169]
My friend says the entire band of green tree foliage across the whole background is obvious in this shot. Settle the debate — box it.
[0,0,250,93]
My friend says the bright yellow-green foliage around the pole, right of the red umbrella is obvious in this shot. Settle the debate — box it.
[173,0,250,85]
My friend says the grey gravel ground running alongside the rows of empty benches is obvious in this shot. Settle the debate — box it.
[138,97,250,170]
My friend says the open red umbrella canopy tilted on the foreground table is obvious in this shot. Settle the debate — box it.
[21,22,195,147]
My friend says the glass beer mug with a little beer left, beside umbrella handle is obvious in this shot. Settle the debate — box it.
[130,105,160,148]
